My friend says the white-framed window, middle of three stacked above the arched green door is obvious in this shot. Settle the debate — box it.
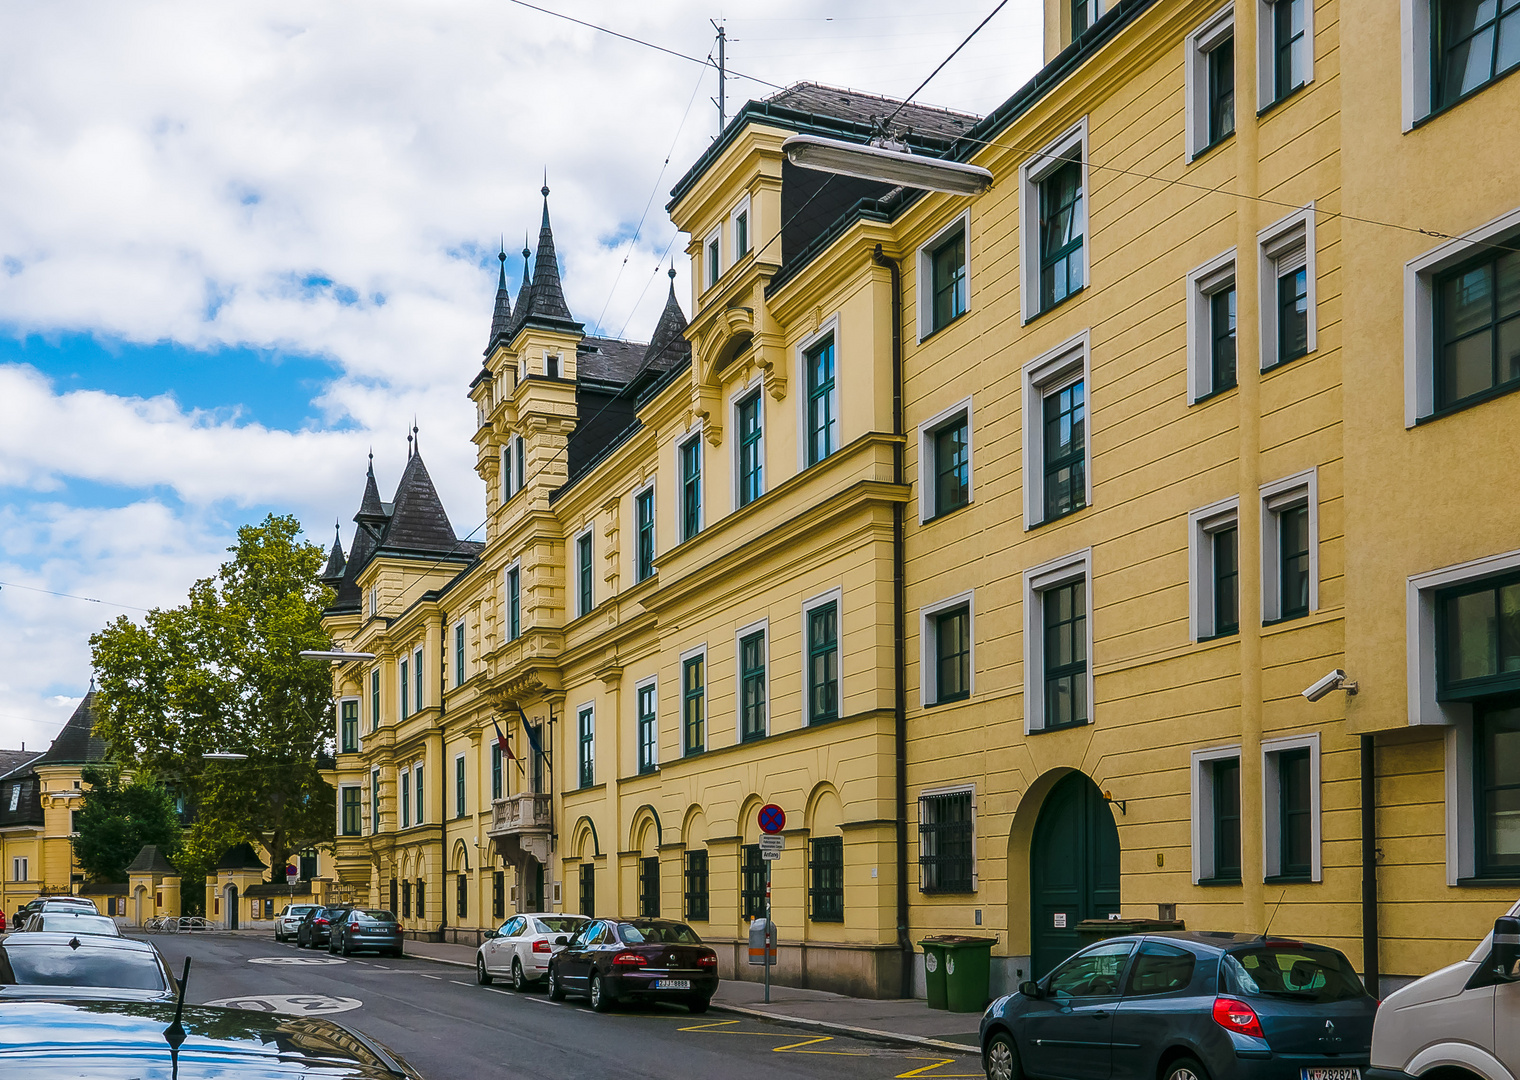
[1023,330,1093,529]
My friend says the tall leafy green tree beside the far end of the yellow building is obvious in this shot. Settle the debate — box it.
[90,515,336,876]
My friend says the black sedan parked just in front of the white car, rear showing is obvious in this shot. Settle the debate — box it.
[549,919,717,1013]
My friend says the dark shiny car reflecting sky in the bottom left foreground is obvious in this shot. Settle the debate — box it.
[0,1002,423,1080]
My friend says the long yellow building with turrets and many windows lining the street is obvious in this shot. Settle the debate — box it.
[314,0,1520,995]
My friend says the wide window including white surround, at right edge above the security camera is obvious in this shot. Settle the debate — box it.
[1404,205,1520,427]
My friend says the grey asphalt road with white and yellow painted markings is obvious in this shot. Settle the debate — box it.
[149,934,982,1080]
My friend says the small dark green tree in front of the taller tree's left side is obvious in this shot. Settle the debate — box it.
[74,767,182,881]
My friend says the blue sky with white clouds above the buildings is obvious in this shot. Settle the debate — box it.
[0,0,1041,749]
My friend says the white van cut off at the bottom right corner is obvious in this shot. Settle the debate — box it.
[1366,904,1520,1080]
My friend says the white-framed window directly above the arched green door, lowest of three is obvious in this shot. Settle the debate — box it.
[1024,548,1093,734]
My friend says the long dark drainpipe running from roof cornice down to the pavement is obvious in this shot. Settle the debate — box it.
[871,245,914,998]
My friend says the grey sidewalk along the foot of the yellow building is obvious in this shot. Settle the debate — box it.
[406,942,982,1053]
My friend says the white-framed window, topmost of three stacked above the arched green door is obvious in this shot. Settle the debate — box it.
[1018,117,1090,322]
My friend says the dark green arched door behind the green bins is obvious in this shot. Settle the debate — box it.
[1029,773,1119,978]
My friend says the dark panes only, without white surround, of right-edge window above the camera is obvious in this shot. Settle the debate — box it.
[1435,247,1520,409]
